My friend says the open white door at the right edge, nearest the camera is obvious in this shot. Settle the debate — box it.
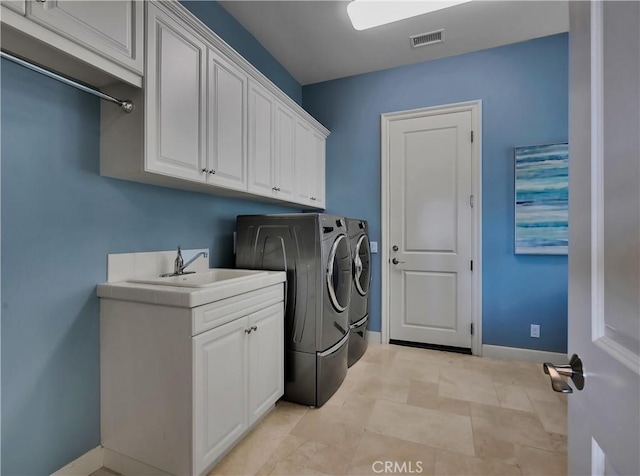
[568,2,640,475]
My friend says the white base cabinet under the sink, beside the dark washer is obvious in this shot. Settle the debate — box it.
[100,282,285,476]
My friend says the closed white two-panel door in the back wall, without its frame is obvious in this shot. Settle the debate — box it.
[388,110,473,348]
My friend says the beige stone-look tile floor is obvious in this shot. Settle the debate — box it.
[210,345,567,476]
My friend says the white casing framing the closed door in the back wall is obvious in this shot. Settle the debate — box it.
[380,100,482,355]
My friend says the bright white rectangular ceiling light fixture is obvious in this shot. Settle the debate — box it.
[347,0,471,31]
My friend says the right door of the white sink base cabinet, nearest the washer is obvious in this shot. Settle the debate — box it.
[248,302,284,425]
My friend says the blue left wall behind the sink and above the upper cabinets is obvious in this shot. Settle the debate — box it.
[0,2,301,476]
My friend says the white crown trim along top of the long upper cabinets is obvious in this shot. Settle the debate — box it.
[149,0,330,138]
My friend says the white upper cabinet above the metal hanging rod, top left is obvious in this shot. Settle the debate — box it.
[2,0,144,87]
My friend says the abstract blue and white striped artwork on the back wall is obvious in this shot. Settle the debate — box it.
[515,143,569,255]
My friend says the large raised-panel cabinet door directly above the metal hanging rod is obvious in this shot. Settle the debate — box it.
[27,0,144,74]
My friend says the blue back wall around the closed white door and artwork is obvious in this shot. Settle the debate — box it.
[303,34,569,352]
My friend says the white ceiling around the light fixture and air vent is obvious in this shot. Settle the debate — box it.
[220,0,569,85]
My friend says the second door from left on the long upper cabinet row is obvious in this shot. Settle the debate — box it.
[207,48,247,190]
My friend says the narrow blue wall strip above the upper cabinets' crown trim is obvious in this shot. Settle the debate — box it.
[180,0,302,104]
